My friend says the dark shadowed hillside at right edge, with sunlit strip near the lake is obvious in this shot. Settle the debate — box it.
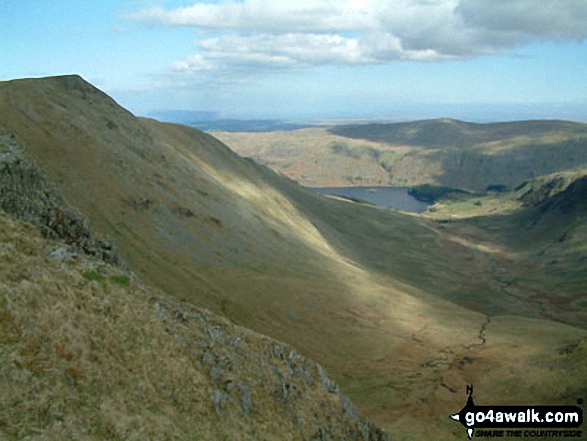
[426,169,587,326]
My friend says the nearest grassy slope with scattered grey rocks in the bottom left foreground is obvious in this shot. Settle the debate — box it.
[0,211,389,440]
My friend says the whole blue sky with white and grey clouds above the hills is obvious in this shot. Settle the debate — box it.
[0,0,587,121]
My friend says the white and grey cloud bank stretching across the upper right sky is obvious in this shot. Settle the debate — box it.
[128,0,587,80]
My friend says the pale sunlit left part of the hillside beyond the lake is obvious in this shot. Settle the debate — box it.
[214,128,424,187]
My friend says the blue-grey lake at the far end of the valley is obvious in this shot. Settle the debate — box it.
[310,187,430,213]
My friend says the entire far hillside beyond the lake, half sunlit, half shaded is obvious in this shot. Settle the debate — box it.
[215,119,587,191]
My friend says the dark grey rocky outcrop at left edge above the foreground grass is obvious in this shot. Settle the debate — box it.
[0,128,122,265]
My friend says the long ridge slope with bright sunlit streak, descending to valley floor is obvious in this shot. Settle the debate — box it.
[0,77,585,439]
